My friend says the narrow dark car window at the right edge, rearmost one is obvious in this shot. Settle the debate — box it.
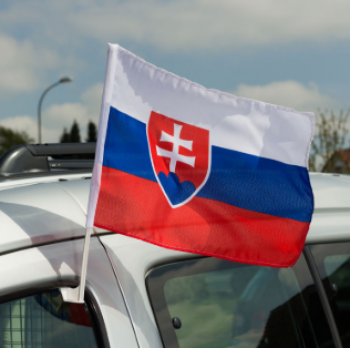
[310,243,350,347]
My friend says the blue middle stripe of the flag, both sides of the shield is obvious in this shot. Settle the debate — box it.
[103,107,313,222]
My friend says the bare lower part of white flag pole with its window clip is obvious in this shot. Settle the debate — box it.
[61,227,93,303]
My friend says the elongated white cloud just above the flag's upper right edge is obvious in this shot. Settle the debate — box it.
[232,80,340,112]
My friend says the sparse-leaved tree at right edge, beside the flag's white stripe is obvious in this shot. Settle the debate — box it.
[309,110,350,172]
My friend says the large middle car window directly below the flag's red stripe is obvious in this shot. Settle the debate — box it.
[147,256,333,348]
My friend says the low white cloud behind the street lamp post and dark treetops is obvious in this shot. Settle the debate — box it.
[0,83,103,143]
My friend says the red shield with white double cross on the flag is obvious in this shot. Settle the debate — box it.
[147,111,211,208]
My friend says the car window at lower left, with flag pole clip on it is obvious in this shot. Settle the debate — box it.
[0,290,98,348]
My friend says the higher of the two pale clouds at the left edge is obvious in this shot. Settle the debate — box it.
[0,33,61,93]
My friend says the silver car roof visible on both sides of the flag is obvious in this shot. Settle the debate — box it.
[0,173,350,254]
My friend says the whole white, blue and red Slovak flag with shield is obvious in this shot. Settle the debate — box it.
[87,45,313,267]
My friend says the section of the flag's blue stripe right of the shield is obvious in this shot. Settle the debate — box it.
[197,146,313,222]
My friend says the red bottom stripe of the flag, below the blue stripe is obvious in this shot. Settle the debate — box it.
[95,167,309,267]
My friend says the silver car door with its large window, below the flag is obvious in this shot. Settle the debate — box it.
[101,235,334,348]
